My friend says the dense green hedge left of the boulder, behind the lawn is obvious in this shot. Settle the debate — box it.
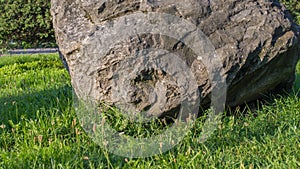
[0,0,55,49]
